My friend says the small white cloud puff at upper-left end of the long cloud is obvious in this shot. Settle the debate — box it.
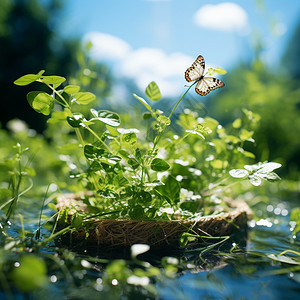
[83,32,131,61]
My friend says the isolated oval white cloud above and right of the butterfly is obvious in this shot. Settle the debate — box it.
[194,2,248,34]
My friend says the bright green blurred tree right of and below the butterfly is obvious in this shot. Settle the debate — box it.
[207,60,300,177]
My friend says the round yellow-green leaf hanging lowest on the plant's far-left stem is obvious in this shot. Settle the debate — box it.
[27,91,54,116]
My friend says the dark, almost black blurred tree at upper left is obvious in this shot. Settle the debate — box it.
[0,0,80,131]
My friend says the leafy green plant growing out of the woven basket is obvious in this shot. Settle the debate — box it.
[14,60,279,220]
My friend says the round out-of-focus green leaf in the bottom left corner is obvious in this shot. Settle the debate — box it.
[10,255,48,292]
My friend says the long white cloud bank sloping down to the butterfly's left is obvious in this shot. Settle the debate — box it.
[84,32,193,97]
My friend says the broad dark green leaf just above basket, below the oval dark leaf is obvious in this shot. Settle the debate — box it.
[155,175,180,205]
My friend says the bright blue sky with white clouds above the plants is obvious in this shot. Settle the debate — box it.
[59,0,300,96]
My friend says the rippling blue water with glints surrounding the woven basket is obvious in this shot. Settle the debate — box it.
[0,197,300,300]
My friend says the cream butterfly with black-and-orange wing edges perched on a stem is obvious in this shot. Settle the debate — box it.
[185,55,225,96]
